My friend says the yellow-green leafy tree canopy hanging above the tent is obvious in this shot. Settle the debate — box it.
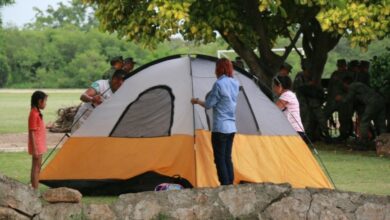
[84,0,390,49]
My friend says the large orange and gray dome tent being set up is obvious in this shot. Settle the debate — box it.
[40,55,332,194]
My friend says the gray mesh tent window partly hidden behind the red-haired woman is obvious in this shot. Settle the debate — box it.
[206,87,261,134]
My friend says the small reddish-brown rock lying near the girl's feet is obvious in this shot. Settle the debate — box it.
[42,187,82,203]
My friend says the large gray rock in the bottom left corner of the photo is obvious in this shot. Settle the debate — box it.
[0,174,42,219]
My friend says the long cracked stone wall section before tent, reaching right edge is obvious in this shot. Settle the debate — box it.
[113,184,390,220]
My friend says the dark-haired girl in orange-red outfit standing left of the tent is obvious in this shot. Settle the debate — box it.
[28,91,47,189]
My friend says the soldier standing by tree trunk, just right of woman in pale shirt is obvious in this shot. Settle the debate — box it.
[293,59,329,141]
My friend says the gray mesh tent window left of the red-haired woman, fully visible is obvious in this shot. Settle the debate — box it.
[110,86,174,138]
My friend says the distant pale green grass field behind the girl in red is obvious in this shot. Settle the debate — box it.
[0,89,83,134]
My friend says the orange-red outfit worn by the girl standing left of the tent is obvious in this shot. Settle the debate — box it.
[28,108,47,155]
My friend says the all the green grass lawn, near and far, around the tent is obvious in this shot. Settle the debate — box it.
[0,90,390,203]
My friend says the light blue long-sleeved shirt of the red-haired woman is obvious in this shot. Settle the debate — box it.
[205,75,239,134]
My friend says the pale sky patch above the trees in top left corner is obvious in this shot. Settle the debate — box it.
[0,0,64,27]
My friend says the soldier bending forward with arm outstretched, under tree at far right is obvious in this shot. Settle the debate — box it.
[336,76,386,149]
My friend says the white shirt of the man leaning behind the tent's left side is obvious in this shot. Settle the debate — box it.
[71,79,113,133]
